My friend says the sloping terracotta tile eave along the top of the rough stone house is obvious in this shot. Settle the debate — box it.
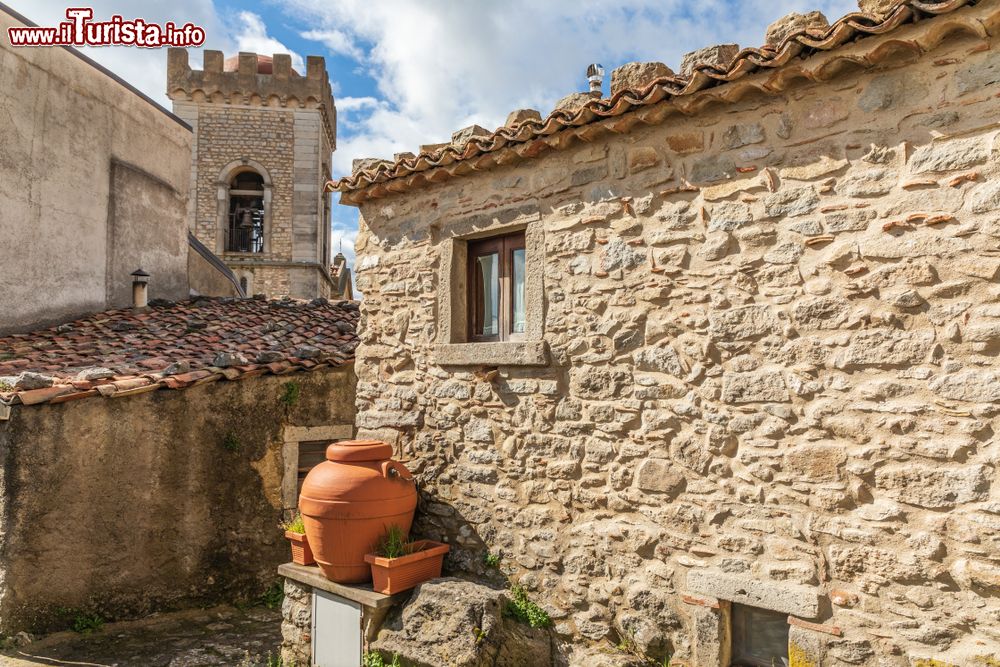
[327,0,984,204]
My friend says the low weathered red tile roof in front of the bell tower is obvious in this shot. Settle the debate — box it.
[0,298,359,408]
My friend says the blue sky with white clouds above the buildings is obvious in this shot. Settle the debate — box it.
[15,0,857,268]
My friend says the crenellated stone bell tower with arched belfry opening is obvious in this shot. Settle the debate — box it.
[167,48,337,299]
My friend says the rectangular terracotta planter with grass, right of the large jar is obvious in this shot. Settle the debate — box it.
[365,525,449,595]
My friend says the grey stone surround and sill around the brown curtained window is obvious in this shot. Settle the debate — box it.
[433,211,549,366]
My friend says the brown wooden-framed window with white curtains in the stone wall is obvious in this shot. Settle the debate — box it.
[468,231,526,342]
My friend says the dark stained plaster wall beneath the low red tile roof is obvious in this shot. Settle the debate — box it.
[0,367,355,634]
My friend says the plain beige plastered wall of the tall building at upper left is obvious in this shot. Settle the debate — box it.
[0,7,191,332]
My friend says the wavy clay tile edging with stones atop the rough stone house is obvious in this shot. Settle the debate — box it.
[326,0,984,204]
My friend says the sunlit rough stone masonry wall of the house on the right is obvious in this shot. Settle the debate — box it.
[357,38,1000,665]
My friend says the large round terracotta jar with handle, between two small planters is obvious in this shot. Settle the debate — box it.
[299,440,417,584]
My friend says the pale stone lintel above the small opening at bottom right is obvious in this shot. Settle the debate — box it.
[687,570,819,618]
